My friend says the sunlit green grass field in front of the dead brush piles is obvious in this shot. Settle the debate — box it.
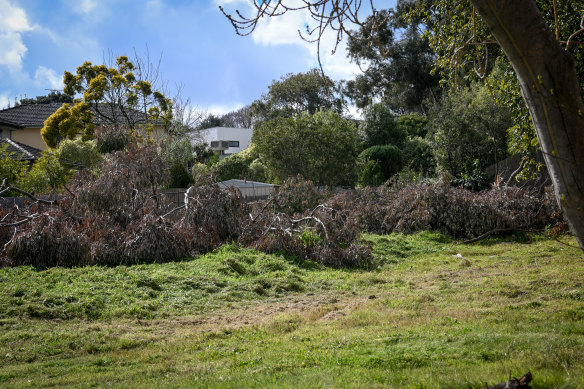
[0,233,584,388]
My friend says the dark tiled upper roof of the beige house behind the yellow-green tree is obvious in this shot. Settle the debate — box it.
[0,103,161,128]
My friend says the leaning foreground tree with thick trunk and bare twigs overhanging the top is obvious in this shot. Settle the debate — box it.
[224,0,584,250]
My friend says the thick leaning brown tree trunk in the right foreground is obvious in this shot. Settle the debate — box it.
[471,0,584,250]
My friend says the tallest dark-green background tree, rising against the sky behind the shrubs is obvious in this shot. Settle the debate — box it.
[346,10,440,113]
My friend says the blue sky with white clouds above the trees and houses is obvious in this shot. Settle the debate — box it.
[0,0,395,114]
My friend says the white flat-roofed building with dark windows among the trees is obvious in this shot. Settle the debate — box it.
[192,127,253,156]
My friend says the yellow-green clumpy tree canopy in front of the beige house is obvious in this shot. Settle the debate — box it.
[41,56,172,148]
